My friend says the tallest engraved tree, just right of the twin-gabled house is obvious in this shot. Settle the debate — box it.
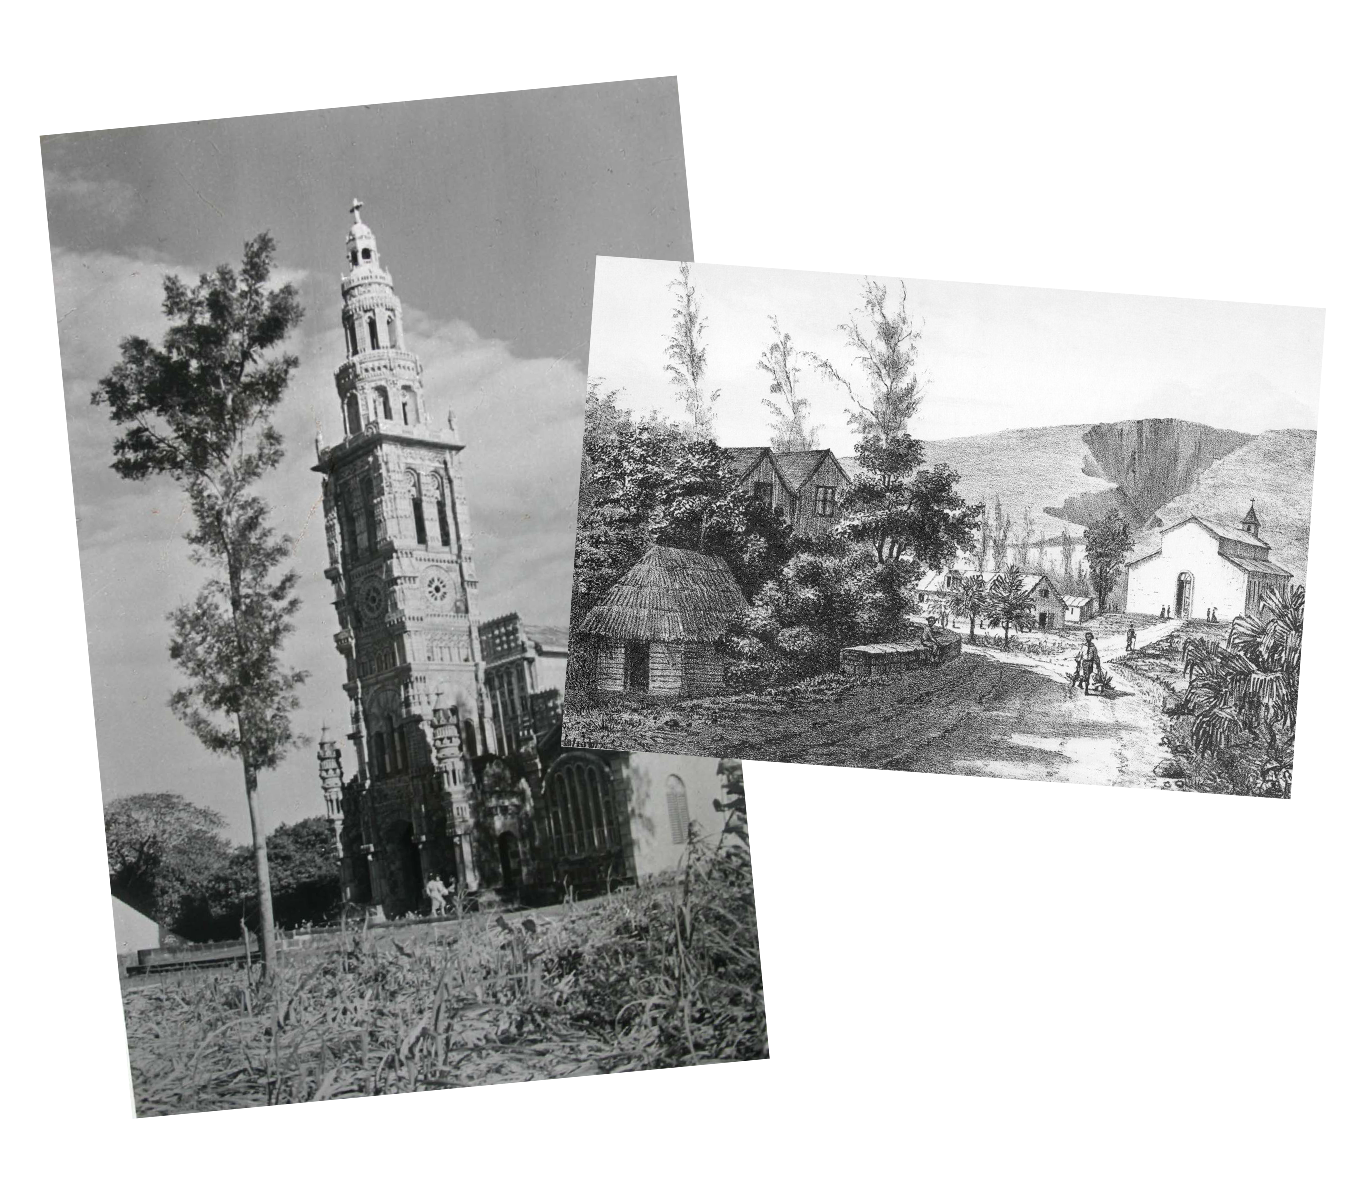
[805,281,983,568]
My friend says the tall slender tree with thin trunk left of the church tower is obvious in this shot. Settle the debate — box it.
[91,233,306,969]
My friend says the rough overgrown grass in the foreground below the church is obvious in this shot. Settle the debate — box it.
[124,845,768,1116]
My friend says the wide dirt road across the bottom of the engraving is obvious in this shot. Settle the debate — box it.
[565,620,1180,783]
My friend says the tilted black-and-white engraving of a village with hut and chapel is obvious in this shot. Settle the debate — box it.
[565,258,1324,798]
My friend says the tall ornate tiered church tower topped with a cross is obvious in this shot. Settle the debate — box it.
[314,199,491,912]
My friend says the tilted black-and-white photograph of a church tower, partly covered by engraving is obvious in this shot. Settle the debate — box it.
[40,88,768,1116]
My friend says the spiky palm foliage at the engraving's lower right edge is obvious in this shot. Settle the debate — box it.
[1183,585,1305,797]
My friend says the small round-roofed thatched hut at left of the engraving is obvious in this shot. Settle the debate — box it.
[578,547,747,696]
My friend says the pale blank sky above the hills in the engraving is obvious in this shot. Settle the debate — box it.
[588,257,1326,456]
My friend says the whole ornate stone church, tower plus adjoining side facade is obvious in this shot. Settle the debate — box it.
[315,202,713,917]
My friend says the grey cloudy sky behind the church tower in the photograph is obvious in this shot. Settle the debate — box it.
[38,85,689,841]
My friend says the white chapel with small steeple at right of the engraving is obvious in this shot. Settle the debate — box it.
[1127,502,1293,622]
